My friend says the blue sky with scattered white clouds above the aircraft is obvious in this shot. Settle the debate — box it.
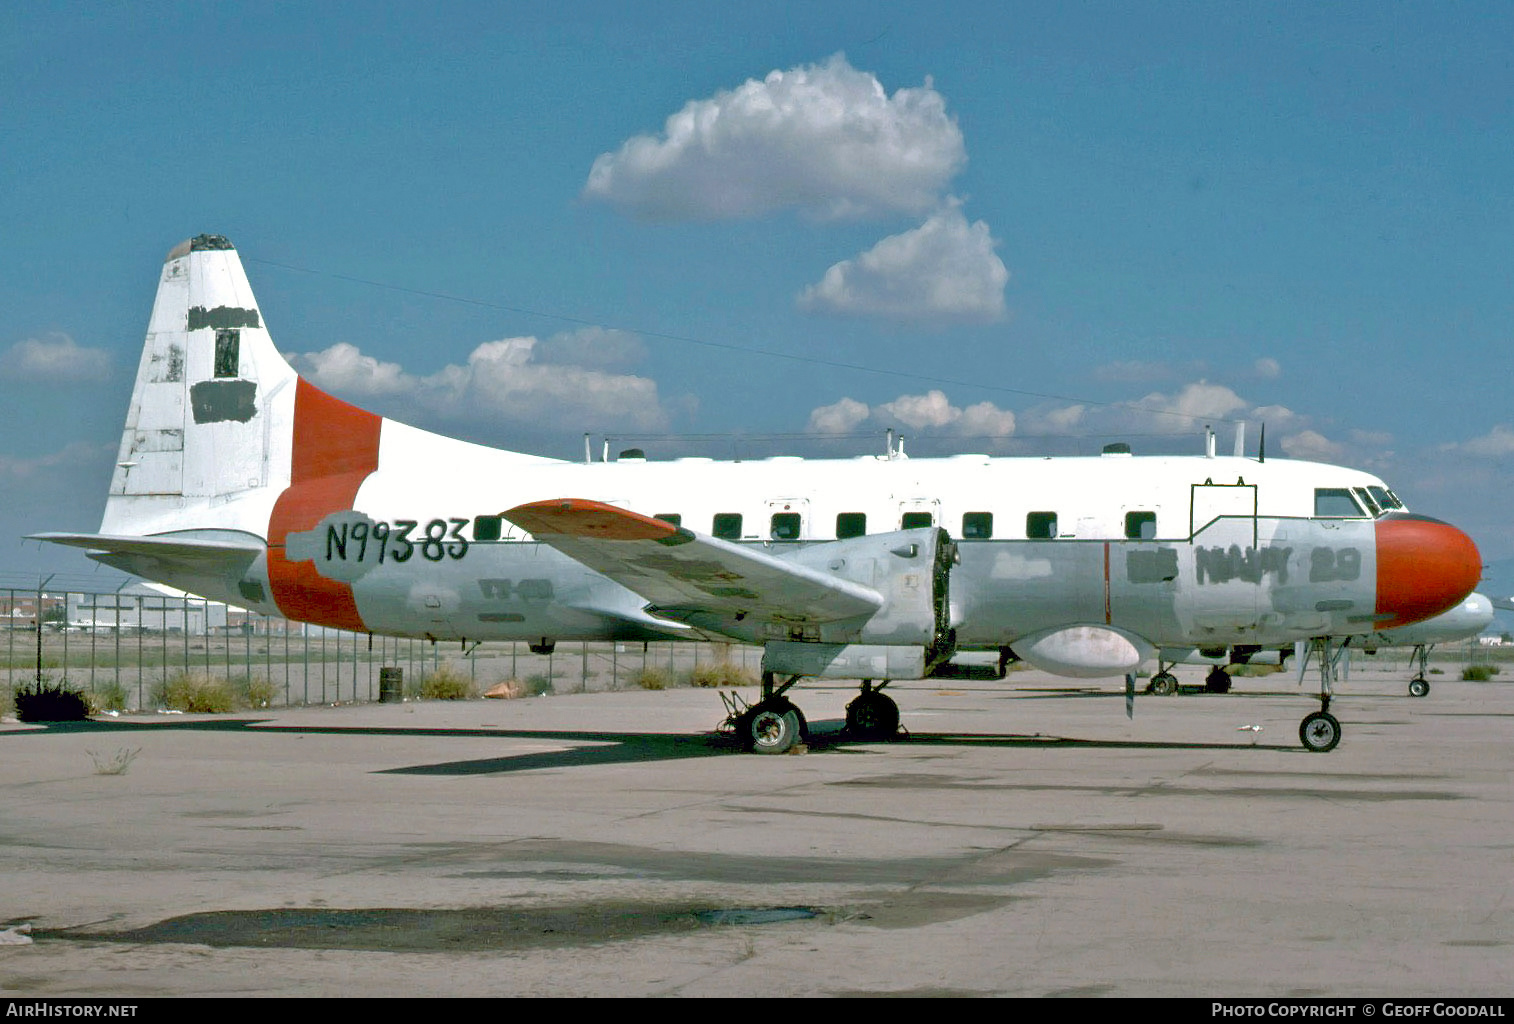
[0,3,1514,587]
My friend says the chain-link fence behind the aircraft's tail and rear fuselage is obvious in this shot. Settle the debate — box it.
[0,588,762,709]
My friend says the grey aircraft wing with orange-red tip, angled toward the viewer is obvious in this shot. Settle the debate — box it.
[504,498,884,624]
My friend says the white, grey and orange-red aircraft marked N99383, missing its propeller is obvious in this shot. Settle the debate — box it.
[32,235,1481,753]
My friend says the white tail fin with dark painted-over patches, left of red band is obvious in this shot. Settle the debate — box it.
[100,235,298,535]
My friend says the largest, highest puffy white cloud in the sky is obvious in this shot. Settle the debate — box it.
[583,55,967,220]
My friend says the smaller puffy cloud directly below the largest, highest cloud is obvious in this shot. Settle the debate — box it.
[798,203,1010,323]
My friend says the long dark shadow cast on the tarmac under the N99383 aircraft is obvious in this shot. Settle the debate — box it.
[8,718,1308,776]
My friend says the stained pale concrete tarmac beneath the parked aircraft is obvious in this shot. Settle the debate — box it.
[0,668,1514,998]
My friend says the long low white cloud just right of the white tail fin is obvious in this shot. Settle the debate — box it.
[292,332,671,433]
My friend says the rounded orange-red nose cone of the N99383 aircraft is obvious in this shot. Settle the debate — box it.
[1378,515,1482,629]
